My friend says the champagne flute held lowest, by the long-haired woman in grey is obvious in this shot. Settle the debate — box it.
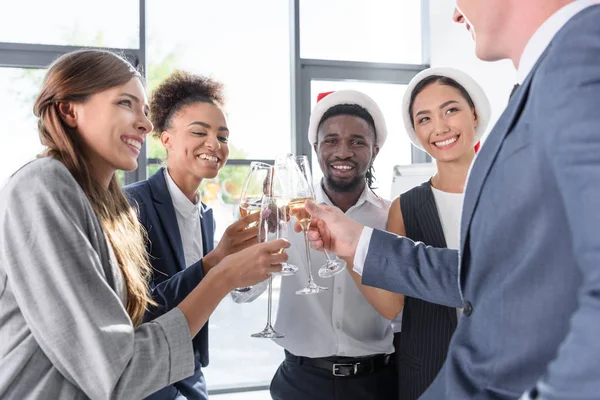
[251,192,298,339]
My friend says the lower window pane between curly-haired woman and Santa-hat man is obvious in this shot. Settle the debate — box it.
[196,166,283,390]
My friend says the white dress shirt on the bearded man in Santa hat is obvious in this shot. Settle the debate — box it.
[232,185,394,358]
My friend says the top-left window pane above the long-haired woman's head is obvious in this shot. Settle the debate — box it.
[0,0,140,49]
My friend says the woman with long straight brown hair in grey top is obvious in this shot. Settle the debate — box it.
[0,50,288,400]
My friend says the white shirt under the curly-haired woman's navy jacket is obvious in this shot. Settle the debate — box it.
[165,168,204,268]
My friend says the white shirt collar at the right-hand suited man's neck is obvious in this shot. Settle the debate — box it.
[517,0,600,84]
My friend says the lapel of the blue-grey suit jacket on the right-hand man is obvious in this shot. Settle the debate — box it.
[459,49,547,264]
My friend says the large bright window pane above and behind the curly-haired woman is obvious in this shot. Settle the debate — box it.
[147,0,291,159]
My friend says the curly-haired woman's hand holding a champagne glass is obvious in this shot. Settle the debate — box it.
[202,213,260,273]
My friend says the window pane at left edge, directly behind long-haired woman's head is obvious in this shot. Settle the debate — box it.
[0,68,45,187]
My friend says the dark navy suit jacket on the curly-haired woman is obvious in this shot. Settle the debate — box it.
[124,168,215,400]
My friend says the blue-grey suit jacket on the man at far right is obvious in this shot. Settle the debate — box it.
[363,6,600,400]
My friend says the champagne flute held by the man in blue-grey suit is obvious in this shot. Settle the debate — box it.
[275,155,328,295]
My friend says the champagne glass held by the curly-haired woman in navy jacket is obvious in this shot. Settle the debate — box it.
[234,161,273,293]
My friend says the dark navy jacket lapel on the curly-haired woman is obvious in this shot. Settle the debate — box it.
[148,168,185,270]
